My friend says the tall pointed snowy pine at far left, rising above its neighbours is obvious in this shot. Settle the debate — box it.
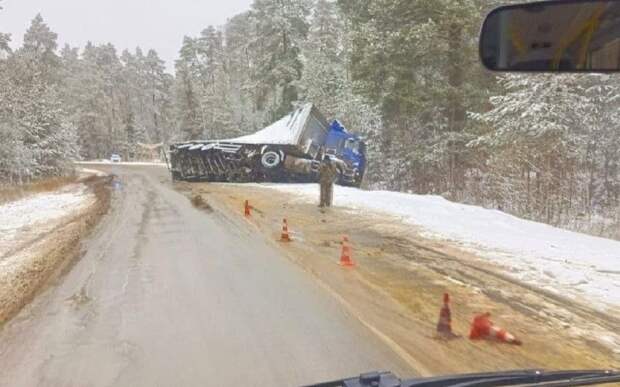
[3,15,76,178]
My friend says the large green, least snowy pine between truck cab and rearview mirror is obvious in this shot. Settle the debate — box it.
[338,0,493,194]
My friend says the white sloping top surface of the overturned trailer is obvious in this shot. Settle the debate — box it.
[218,103,312,144]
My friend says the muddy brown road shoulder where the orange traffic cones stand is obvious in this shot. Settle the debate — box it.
[177,183,620,374]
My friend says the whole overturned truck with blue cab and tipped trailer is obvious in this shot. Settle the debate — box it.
[170,104,366,186]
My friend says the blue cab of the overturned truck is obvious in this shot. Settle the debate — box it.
[325,120,366,187]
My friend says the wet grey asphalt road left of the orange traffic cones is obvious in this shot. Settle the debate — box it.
[0,166,413,386]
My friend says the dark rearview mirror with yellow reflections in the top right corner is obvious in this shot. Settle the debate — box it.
[480,0,620,72]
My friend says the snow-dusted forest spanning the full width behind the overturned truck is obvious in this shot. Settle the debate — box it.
[0,0,620,238]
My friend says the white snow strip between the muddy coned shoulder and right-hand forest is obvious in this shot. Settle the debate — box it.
[261,184,620,310]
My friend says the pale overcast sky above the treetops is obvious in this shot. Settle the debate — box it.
[0,0,252,70]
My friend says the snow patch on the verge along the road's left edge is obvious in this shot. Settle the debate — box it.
[0,184,94,257]
